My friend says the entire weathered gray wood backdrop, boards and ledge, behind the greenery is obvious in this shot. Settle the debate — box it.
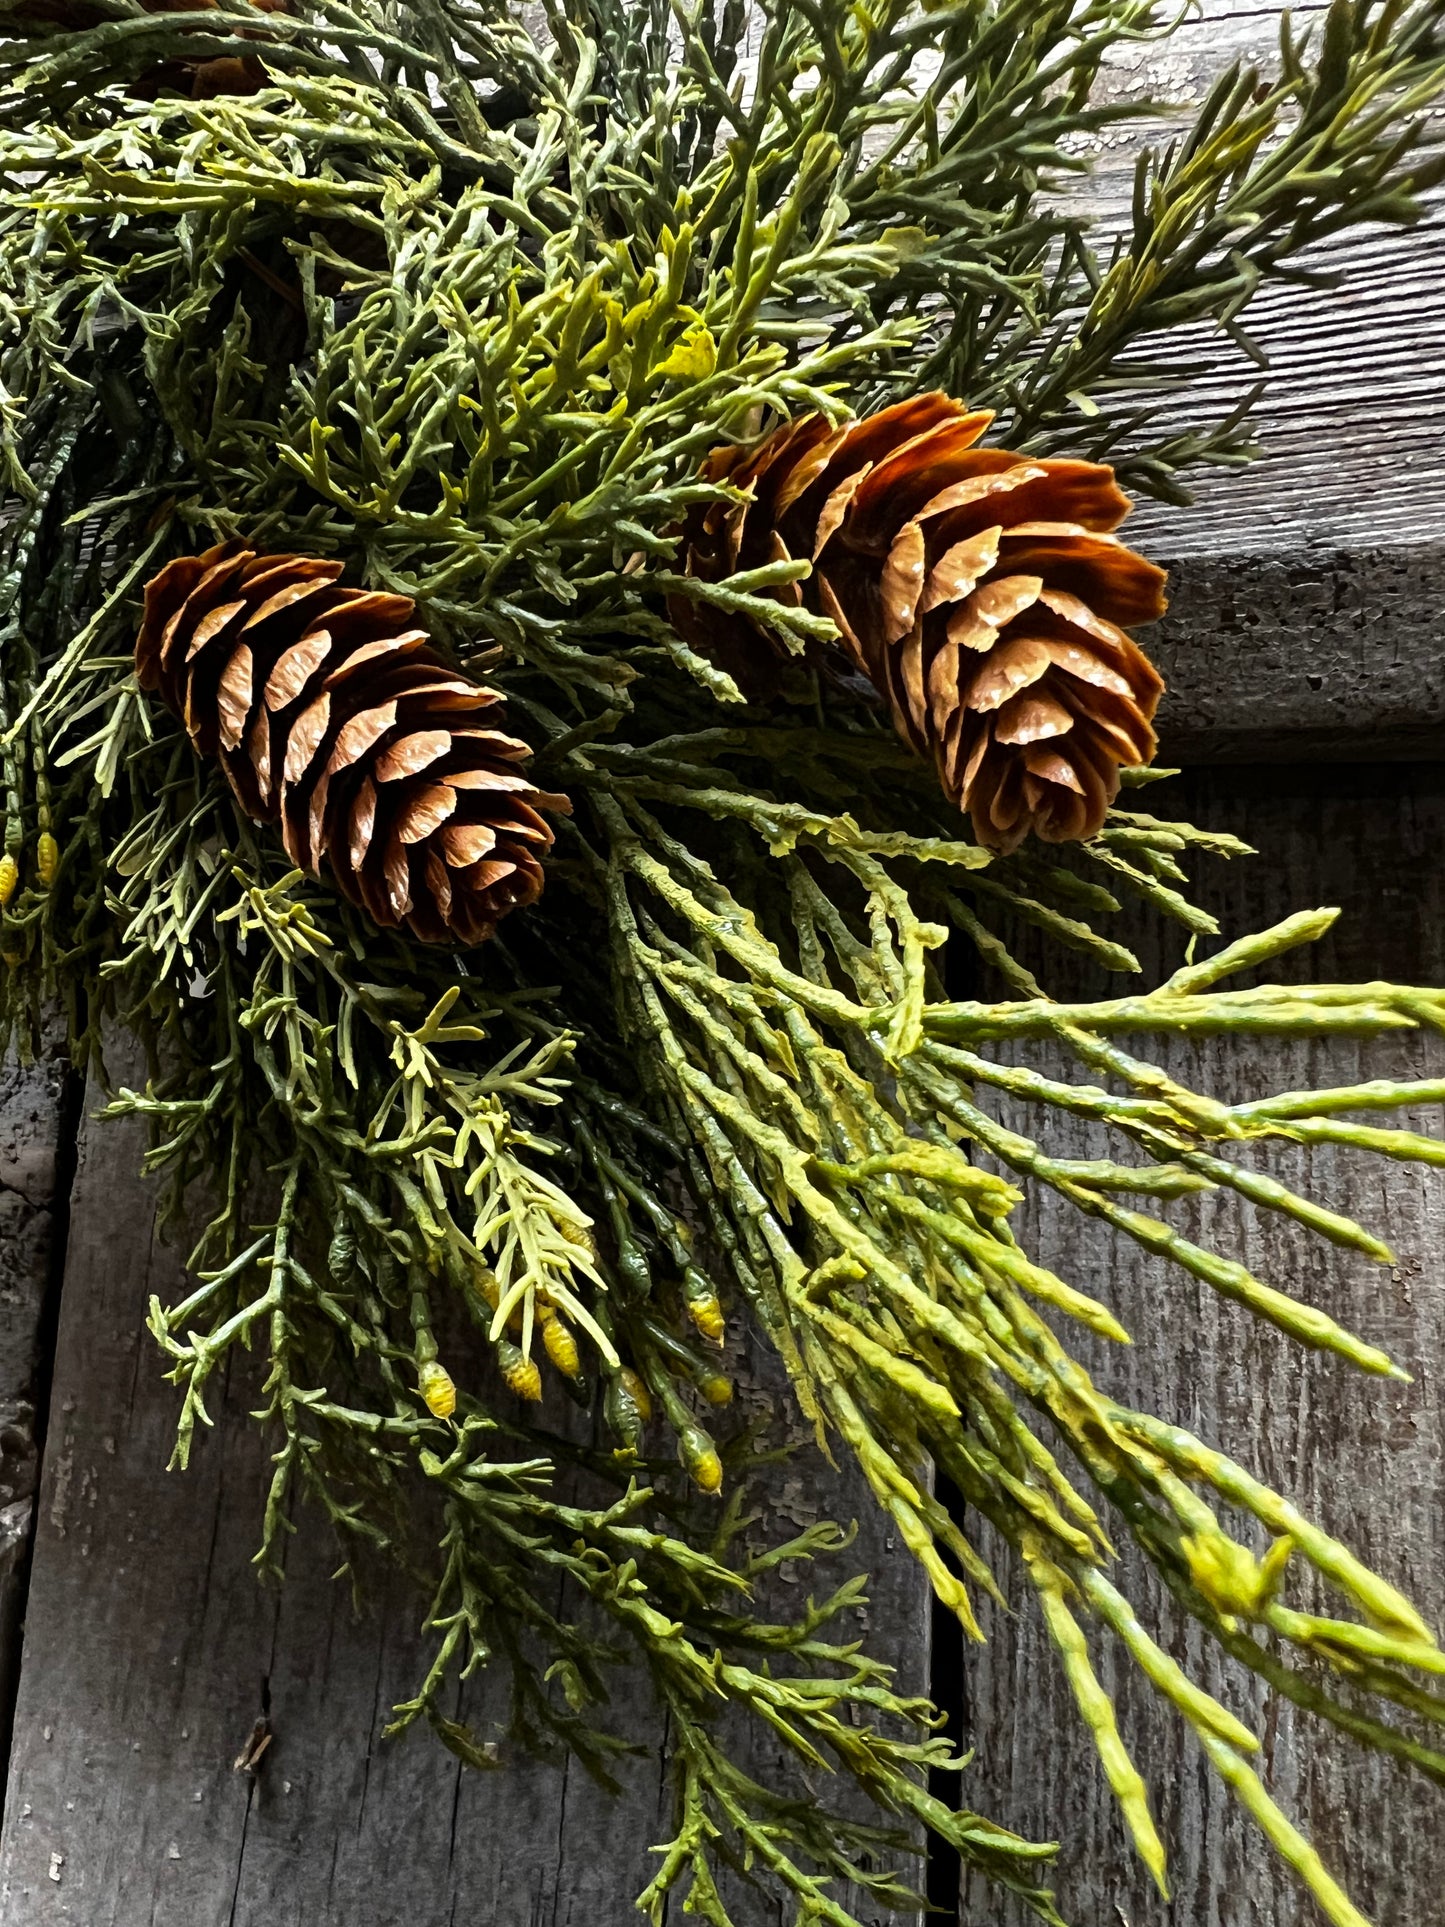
[0,0,1445,1927]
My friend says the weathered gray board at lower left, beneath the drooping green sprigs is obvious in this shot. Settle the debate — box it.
[0,1071,927,1927]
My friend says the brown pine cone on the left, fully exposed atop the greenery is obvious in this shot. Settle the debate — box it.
[135,541,570,944]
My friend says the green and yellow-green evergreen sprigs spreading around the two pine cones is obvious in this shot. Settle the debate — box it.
[0,0,1445,1927]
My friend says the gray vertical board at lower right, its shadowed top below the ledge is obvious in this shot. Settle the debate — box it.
[965,767,1445,1927]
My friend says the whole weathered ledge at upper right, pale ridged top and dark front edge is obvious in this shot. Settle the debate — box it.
[1079,0,1445,761]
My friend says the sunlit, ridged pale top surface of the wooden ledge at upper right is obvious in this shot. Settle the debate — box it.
[1075,0,1445,568]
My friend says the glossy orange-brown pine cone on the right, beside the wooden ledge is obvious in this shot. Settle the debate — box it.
[669,393,1164,850]
